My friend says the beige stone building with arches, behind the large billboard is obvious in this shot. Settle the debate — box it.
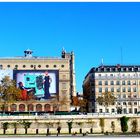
[0,49,76,111]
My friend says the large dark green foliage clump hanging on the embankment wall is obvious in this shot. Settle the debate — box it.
[120,116,129,133]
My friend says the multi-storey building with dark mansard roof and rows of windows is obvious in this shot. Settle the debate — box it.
[83,65,140,114]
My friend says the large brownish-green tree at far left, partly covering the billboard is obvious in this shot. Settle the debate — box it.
[0,76,21,112]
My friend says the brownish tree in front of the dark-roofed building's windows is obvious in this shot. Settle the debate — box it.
[96,92,117,110]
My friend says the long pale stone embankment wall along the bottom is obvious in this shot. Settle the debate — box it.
[0,115,140,134]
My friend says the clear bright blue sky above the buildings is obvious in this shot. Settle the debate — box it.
[0,2,140,91]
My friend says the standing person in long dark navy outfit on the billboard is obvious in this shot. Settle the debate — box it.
[44,71,52,99]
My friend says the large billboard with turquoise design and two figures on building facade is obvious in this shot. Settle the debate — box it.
[0,70,59,100]
